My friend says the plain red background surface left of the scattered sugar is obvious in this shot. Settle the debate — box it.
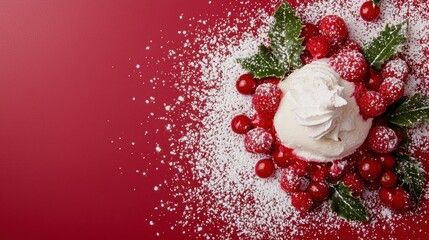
[0,0,428,240]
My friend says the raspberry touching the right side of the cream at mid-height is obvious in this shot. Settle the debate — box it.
[358,91,386,120]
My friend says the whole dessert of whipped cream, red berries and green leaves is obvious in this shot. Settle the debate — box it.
[231,1,429,221]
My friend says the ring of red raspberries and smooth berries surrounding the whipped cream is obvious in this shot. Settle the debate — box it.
[231,15,411,212]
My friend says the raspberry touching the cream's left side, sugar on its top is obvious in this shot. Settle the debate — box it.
[252,83,282,118]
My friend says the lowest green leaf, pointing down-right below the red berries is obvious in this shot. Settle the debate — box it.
[331,181,369,222]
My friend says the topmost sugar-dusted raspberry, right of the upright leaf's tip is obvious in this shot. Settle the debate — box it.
[319,15,348,44]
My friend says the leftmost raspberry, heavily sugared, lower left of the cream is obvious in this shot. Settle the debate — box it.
[244,127,274,153]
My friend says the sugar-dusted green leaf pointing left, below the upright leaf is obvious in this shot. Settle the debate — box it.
[237,45,286,78]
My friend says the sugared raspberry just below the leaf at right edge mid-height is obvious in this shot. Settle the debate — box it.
[368,126,398,153]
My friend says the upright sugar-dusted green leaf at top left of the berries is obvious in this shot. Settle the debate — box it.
[268,3,304,70]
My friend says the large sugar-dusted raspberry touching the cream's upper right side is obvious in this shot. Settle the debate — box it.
[329,51,367,82]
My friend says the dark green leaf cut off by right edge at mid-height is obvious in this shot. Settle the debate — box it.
[387,94,429,128]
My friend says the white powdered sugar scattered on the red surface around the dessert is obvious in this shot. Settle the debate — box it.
[131,0,429,239]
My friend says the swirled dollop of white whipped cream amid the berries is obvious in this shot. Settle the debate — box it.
[274,59,372,162]
